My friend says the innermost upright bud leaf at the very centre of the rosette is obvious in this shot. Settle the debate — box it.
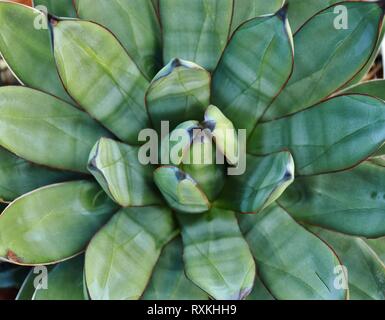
[181,129,226,201]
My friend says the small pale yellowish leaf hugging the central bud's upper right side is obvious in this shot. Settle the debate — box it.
[204,105,240,165]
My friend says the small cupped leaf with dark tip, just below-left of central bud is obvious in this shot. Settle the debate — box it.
[154,166,210,213]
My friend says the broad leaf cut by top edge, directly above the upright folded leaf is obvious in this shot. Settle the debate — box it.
[159,0,233,71]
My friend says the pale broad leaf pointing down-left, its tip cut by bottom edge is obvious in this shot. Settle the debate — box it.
[85,207,176,300]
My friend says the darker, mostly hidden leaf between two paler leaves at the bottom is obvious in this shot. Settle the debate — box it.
[143,238,208,300]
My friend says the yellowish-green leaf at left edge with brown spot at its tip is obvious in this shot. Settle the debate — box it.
[0,181,116,265]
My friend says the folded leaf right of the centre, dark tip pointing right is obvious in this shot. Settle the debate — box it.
[215,152,294,213]
